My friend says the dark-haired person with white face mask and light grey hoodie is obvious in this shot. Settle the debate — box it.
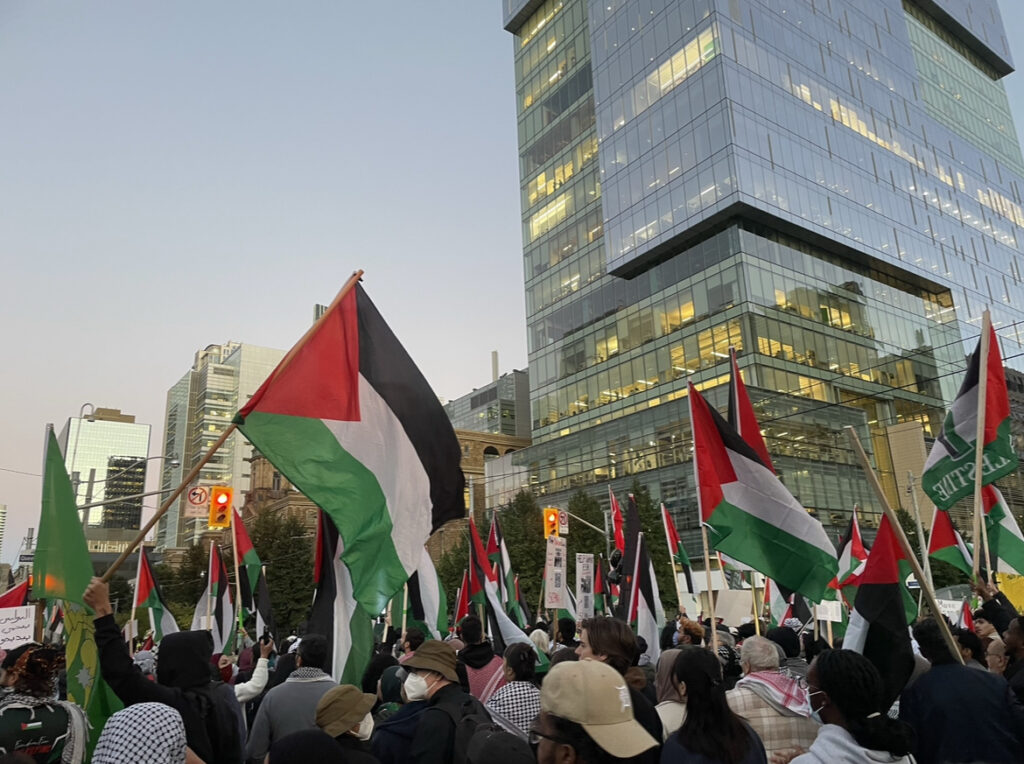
[792,650,913,764]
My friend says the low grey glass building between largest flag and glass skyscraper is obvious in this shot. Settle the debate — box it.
[444,369,529,437]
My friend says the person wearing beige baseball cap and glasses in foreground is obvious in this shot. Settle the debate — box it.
[529,659,658,764]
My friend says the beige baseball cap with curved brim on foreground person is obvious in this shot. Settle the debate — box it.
[541,661,657,759]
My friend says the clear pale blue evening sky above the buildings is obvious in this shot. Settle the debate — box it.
[0,0,1024,560]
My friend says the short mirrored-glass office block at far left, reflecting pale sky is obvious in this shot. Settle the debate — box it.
[57,409,151,539]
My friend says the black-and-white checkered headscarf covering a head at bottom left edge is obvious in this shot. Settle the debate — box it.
[92,703,185,764]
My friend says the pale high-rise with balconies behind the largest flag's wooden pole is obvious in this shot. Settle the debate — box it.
[156,342,285,550]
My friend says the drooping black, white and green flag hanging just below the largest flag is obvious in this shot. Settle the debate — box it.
[306,510,378,686]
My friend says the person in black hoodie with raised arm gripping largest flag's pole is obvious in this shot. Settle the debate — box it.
[84,578,245,764]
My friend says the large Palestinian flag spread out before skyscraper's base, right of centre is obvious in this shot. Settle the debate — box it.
[689,383,839,602]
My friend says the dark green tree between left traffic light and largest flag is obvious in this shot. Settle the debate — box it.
[249,511,314,638]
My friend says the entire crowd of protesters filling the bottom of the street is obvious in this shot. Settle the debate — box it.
[0,579,1024,764]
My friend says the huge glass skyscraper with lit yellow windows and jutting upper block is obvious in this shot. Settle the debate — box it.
[495,0,1024,540]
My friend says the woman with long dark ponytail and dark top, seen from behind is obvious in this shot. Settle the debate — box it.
[662,647,767,764]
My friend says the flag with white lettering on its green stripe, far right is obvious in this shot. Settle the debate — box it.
[921,326,1017,509]
